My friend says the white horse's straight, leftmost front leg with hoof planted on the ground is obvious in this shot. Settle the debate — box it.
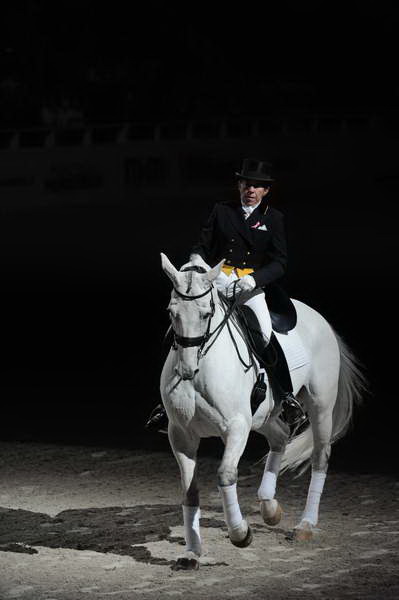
[168,422,201,570]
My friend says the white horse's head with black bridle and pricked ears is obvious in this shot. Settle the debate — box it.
[161,254,224,379]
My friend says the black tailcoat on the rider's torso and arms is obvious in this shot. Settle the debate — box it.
[192,201,287,287]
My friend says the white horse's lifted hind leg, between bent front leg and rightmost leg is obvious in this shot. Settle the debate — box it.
[258,417,289,525]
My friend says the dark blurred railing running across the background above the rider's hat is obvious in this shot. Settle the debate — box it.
[0,114,384,150]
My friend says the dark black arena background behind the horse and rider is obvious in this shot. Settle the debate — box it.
[0,1,399,471]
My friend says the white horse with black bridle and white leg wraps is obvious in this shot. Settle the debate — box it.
[160,254,365,569]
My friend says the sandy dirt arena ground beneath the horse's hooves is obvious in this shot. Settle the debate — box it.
[0,442,399,600]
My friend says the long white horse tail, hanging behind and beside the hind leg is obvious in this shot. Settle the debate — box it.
[280,332,368,475]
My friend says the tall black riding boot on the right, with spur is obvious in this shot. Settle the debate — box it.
[262,333,307,429]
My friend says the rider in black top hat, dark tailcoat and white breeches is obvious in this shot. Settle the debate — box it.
[146,158,303,430]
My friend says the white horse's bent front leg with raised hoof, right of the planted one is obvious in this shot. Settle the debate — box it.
[218,417,252,548]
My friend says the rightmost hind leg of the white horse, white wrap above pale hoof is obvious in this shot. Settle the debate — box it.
[294,385,337,541]
